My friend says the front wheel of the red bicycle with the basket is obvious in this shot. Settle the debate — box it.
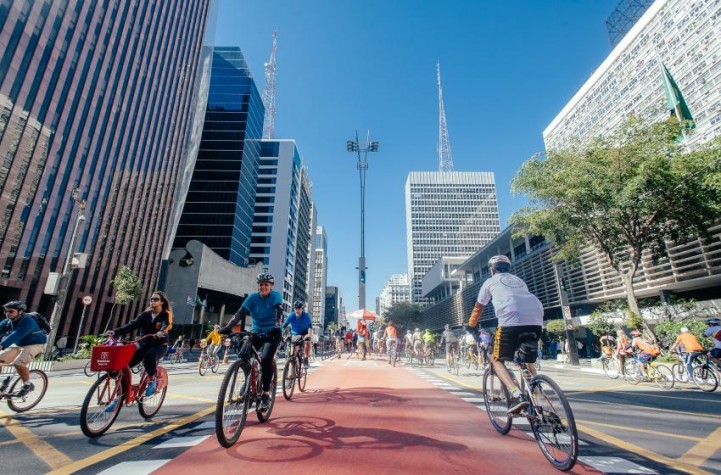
[80,373,123,437]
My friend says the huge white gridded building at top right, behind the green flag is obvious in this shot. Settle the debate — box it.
[543,0,721,149]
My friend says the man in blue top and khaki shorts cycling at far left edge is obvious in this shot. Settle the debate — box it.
[0,300,48,397]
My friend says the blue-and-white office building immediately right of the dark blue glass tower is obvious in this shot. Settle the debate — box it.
[250,140,312,311]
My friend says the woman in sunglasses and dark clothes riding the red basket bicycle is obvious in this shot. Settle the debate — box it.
[107,291,173,398]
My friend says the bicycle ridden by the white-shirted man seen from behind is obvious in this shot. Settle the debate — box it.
[483,334,578,472]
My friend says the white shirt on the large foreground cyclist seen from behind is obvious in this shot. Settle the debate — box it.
[477,272,543,327]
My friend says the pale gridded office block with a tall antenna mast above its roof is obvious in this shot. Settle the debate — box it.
[405,172,500,304]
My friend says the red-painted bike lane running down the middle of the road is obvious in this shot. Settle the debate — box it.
[153,358,600,475]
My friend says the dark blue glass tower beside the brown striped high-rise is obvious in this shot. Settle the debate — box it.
[173,47,265,266]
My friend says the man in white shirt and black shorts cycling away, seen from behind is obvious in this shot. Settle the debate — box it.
[468,255,543,414]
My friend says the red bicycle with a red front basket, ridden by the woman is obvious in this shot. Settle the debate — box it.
[80,335,168,438]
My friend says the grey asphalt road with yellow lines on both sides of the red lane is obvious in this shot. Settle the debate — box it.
[0,358,721,474]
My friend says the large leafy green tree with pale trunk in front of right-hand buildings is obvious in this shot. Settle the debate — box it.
[511,118,721,333]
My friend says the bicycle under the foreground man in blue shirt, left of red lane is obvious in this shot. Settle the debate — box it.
[215,333,278,448]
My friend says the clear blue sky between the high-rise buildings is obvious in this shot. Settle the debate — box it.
[215,0,617,311]
